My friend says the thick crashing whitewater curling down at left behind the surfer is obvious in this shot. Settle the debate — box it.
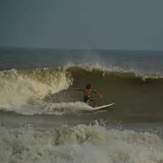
[0,69,72,110]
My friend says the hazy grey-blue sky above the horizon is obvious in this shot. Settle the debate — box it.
[0,0,163,50]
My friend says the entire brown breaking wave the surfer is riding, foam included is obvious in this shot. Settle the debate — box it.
[0,64,163,116]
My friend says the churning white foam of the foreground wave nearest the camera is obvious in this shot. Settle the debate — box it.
[0,125,163,163]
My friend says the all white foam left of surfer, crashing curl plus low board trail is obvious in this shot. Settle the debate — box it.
[0,69,93,115]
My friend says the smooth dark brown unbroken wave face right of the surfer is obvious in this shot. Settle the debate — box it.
[66,67,163,120]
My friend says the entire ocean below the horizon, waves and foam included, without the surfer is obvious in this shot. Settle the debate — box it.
[0,48,163,163]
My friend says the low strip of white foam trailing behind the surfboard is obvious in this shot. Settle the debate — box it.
[8,101,92,115]
